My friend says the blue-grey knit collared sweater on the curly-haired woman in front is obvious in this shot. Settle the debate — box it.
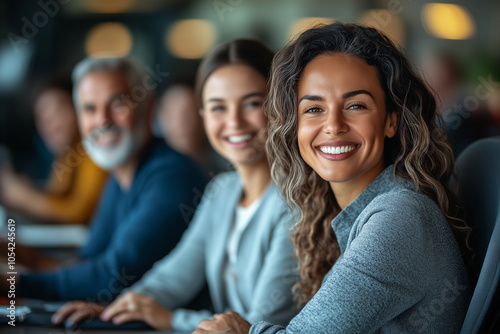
[250,166,471,334]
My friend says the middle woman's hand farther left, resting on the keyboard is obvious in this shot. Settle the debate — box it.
[51,301,105,325]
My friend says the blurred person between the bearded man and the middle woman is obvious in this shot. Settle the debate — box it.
[157,82,230,177]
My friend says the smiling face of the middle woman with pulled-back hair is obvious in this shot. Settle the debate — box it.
[202,64,267,166]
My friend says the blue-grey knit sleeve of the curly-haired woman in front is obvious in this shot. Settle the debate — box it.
[250,194,433,334]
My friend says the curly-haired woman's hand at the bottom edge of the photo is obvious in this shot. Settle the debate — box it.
[192,312,252,334]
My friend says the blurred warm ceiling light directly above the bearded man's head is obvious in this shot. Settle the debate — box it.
[85,22,132,57]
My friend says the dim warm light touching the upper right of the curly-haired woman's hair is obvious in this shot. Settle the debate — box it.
[359,9,406,46]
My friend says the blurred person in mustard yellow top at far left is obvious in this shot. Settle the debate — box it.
[0,78,107,224]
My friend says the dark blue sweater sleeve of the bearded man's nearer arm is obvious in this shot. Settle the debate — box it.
[19,157,204,304]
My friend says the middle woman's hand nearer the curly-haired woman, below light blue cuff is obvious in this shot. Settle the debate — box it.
[101,291,172,330]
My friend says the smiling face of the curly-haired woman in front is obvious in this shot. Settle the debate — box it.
[297,54,397,199]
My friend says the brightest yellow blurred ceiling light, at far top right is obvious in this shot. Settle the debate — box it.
[422,3,476,39]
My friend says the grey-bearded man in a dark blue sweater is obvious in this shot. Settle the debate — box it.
[0,57,206,302]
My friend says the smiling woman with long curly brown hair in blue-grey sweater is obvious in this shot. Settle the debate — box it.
[196,23,470,333]
